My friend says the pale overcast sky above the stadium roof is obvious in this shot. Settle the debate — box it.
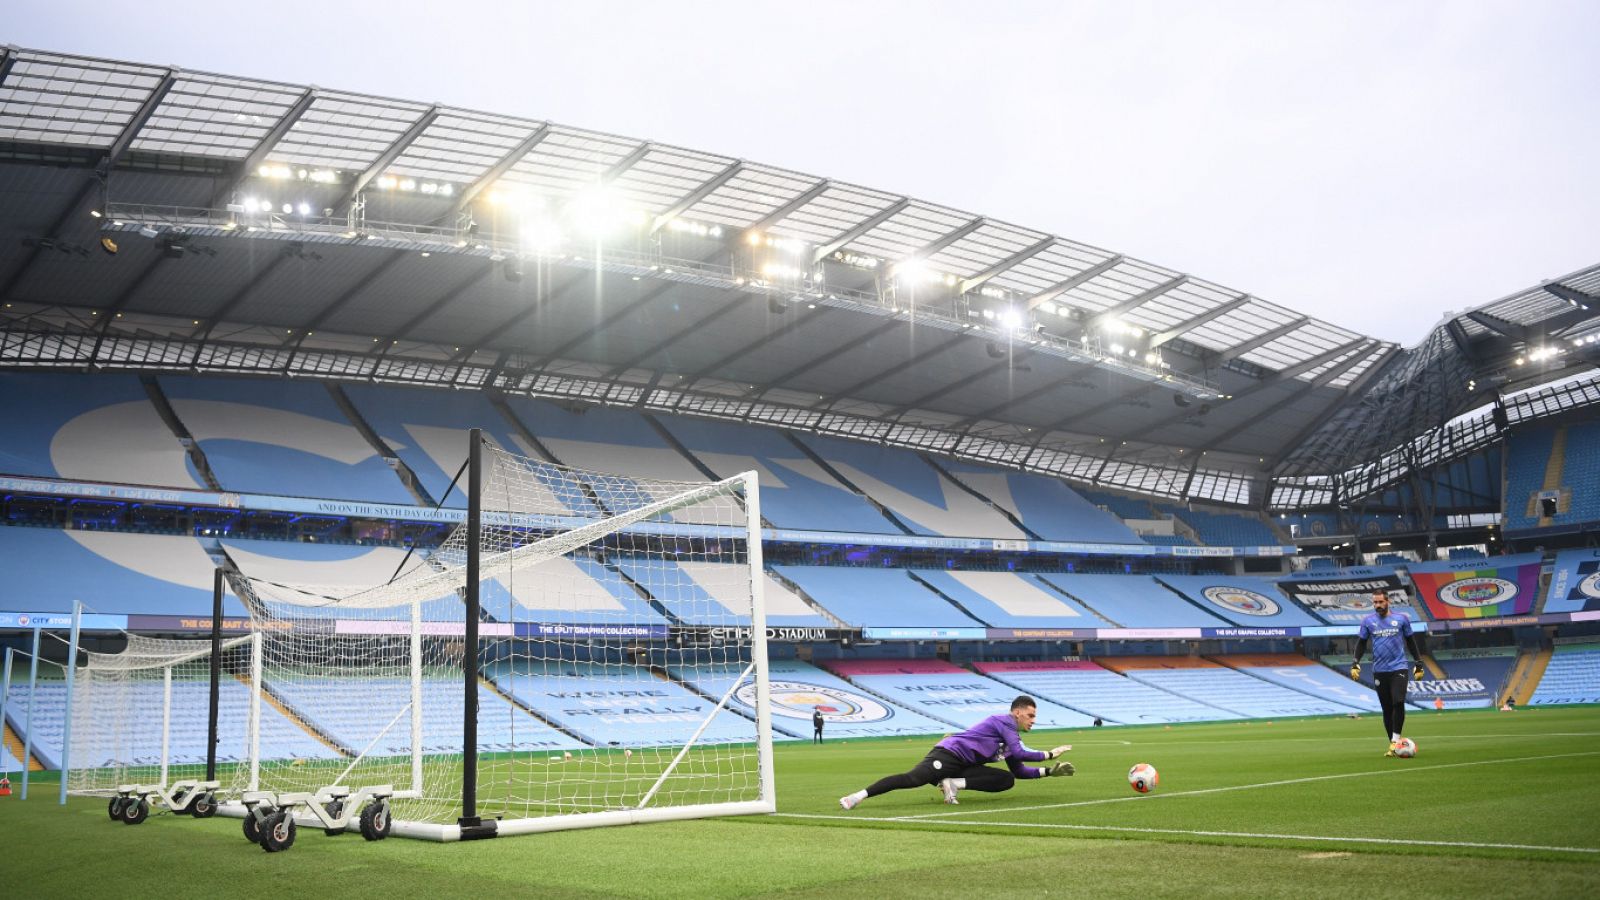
[0,0,1600,346]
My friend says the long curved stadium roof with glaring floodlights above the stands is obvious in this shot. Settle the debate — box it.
[0,48,1600,504]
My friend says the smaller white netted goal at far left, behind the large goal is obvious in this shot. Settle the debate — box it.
[66,634,259,796]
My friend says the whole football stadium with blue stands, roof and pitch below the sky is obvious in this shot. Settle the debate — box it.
[0,38,1600,897]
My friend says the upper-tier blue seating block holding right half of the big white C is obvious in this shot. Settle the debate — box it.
[160,376,414,504]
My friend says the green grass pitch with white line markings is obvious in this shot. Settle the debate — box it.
[0,706,1600,900]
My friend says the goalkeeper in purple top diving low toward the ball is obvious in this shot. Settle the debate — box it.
[838,695,1074,809]
